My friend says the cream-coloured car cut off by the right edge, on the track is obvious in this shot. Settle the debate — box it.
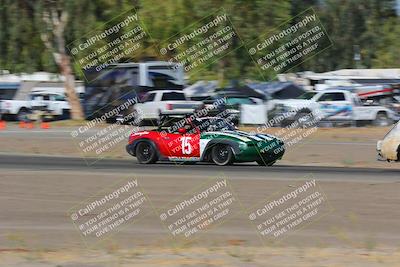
[376,122,400,161]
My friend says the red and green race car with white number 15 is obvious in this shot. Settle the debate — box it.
[126,117,285,166]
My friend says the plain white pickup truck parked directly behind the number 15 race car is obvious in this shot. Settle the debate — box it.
[134,90,203,123]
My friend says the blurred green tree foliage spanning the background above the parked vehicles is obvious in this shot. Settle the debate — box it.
[0,0,400,83]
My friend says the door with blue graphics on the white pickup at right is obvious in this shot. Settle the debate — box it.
[316,92,353,120]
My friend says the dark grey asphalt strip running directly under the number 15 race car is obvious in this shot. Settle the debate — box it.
[0,154,400,181]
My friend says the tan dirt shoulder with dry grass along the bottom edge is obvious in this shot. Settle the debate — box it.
[0,246,400,267]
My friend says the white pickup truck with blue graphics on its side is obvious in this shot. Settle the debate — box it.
[268,90,398,126]
